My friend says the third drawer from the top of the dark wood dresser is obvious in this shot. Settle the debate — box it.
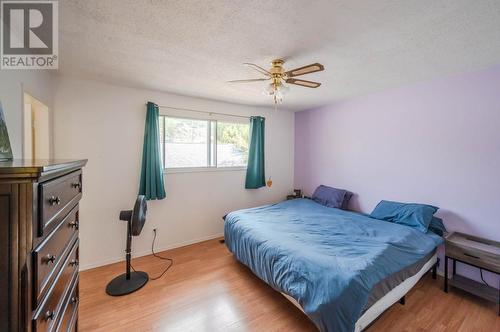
[33,241,78,331]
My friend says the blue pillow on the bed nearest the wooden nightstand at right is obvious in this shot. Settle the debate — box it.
[370,201,438,233]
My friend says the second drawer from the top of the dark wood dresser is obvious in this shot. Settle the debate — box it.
[33,205,79,303]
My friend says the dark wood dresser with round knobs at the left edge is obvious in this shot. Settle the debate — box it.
[0,160,87,331]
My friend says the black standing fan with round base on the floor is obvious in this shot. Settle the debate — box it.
[106,195,149,296]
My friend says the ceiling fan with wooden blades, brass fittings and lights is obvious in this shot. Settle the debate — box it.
[229,59,325,107]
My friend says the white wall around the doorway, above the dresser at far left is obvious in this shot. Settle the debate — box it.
[0,70,55,159]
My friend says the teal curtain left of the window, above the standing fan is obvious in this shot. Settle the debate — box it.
[139,102,166,200]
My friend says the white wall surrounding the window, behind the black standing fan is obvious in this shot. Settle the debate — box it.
[54,77,294,269]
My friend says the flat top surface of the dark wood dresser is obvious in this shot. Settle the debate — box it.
[0,159,87,178]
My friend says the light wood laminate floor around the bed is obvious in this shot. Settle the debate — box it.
[79,240,500,332]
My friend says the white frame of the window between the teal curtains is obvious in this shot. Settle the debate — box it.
[160,112,250,174]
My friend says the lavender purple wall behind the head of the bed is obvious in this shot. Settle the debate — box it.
[295,66,500,285]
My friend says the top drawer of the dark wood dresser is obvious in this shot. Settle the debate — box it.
[38,171,82,236]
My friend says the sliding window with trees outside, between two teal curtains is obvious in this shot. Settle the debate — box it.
[160,116,249,169]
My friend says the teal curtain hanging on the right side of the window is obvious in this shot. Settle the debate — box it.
[245,116,266,189]
